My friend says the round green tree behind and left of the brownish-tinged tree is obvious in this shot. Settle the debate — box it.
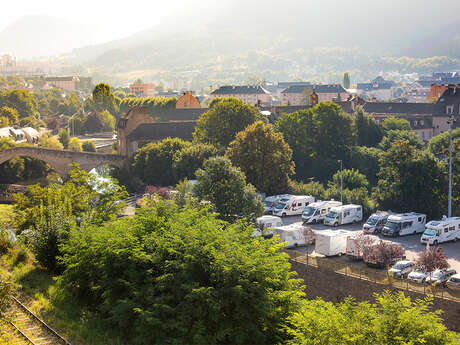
[193,98,264,150]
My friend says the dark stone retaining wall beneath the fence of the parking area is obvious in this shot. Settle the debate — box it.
[291,260,460,332]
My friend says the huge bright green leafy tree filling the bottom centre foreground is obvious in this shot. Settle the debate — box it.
[59,202,302,344]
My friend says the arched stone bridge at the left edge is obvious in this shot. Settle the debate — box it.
[0,146,127,177]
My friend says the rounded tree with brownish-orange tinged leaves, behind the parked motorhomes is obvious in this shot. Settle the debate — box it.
[226,121,294,194]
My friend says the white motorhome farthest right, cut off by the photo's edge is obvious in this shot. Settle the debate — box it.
[420,217,460,245]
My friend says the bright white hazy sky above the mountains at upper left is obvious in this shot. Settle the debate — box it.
[0,0,187,40]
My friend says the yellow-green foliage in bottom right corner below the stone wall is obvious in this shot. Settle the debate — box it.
[287,292,455,345]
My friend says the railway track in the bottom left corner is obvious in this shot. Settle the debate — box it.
[1,297,71,345]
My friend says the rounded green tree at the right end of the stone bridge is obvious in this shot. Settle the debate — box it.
[132,138,191,186]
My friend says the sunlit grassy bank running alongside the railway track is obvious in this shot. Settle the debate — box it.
[0,244,123,345]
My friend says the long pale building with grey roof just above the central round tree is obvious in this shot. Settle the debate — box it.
[211,85,272,106]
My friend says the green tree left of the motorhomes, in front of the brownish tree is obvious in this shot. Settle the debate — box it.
[194,157,263,220]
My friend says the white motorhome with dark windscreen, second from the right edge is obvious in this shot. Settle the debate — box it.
[382,212,426,236]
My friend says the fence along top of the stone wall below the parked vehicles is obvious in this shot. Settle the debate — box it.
[286,250,460,303]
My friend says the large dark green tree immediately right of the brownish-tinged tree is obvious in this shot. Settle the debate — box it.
[276,102,356,181]
